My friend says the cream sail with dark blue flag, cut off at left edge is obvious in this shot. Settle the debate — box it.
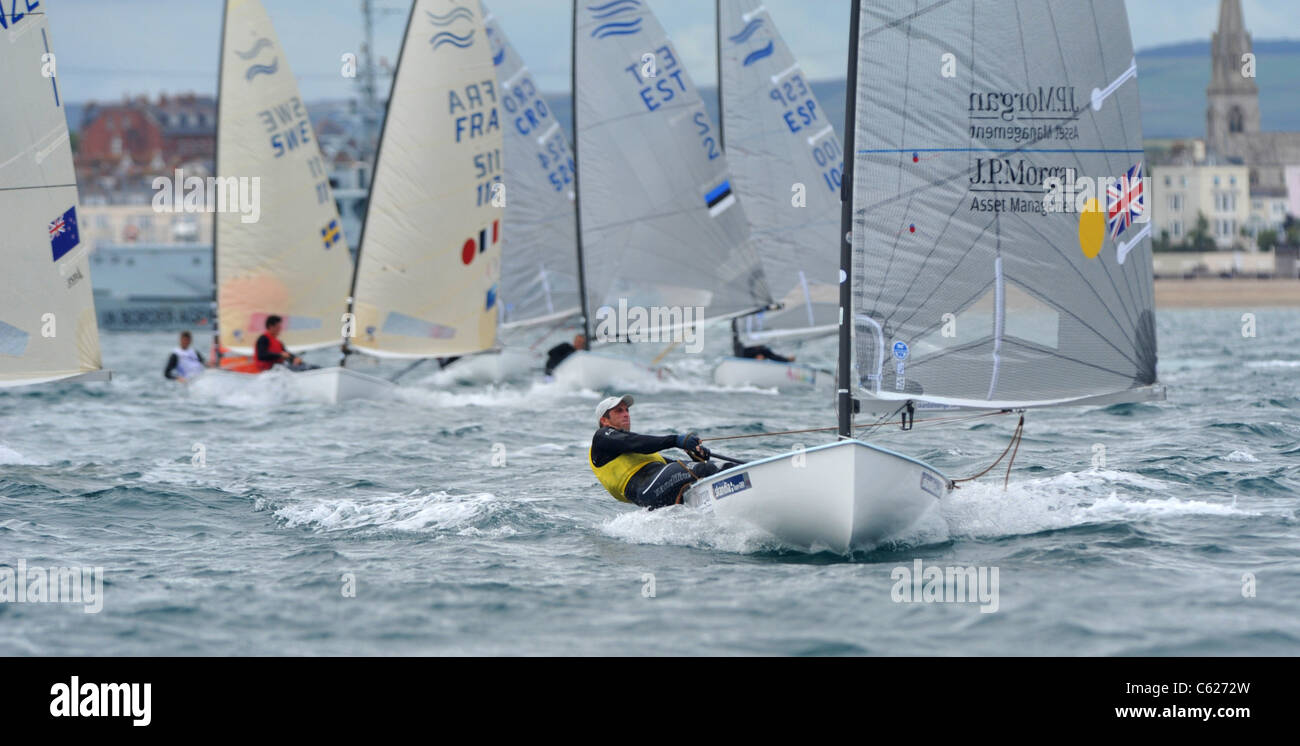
[0,5,111,389]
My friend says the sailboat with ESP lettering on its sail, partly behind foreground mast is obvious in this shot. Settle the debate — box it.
[714,0,844,389]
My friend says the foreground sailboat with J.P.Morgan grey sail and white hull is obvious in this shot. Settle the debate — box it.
[685,0,1164,552]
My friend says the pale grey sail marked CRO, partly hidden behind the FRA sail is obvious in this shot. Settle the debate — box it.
[484,6,579,326]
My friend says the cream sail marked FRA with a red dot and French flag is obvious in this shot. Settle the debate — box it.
[351,0,510,357]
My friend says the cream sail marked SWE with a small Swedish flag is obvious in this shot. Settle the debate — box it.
[213,0,352,354]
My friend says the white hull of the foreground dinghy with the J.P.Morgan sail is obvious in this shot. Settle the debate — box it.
[683,441,952,554]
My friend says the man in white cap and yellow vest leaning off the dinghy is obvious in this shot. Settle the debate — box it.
[588,395,719,509]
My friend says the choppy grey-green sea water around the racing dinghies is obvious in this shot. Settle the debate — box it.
[0,309,1300,655]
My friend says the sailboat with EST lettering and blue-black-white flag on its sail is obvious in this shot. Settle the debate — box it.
[555,0,772,389]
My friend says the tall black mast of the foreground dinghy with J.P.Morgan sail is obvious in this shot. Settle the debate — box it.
[836,0,862,438]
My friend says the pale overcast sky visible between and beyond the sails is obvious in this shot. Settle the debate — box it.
[50,0,1300,101]
